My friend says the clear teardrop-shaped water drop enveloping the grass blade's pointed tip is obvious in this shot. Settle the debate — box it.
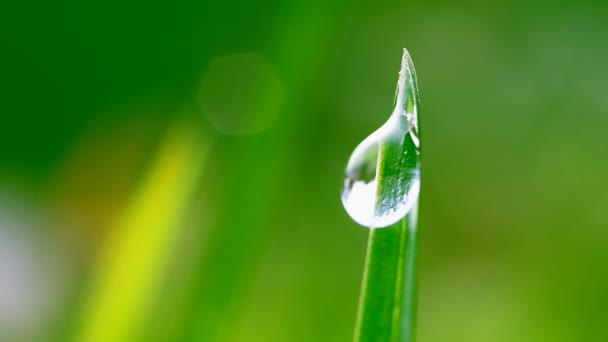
[342,49,420,228]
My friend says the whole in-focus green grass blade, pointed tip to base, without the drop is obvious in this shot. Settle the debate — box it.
[354,50,420,342]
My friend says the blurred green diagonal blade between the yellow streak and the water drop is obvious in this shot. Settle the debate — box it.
[179,0,343,341]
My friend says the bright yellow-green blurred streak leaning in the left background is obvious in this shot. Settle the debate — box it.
[76,121,209,342]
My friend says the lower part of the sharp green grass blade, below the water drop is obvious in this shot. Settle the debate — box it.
[354,192,418,342]
